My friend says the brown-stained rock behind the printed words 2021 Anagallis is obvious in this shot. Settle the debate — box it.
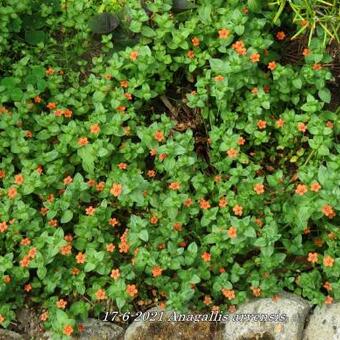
[124,307,223,340]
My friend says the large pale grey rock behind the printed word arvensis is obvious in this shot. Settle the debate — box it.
[224,293,312,340]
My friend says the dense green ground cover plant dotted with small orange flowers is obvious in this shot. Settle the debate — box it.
[0,0,340,339]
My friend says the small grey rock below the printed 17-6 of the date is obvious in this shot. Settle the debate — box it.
[77,319,124,340]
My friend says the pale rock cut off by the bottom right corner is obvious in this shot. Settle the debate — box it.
[303,302,340,340]
